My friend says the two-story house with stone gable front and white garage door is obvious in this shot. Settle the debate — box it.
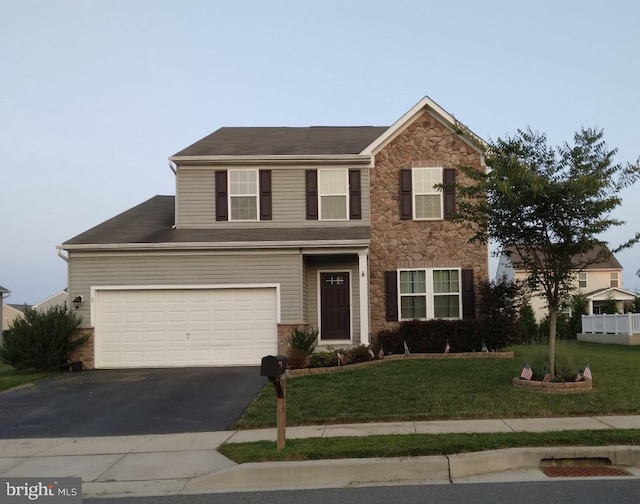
[58,98,489,368]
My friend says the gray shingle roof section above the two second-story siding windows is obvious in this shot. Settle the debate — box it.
[174,126,388,156]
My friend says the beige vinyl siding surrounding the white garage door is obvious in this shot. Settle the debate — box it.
[69,251,302,326]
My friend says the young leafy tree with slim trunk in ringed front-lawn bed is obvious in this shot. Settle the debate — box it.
[457,127,640,377]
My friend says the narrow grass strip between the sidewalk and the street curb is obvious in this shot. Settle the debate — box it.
[218,429,640,464]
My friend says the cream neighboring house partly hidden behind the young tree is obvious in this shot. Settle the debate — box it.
[496,247,635,321]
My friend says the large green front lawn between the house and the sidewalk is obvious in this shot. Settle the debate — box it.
[233,341,640,429]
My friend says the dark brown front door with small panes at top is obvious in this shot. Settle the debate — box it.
[320,272,351,340]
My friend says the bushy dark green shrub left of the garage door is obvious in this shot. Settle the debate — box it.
[0,306,88,371]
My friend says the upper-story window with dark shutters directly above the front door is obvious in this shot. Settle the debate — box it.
[305,168,362,221]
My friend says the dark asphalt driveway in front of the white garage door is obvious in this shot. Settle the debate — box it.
[0,367,267,439]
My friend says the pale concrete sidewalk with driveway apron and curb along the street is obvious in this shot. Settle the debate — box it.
[0,415,640,497]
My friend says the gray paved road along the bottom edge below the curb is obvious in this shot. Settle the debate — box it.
[82,479,640,504]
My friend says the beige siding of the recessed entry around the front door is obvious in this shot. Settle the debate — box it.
[306,257,360,344]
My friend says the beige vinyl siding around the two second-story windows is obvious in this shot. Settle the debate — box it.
[177,167,370,229]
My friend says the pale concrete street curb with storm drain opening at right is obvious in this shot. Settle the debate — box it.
[184,446,640,493]
